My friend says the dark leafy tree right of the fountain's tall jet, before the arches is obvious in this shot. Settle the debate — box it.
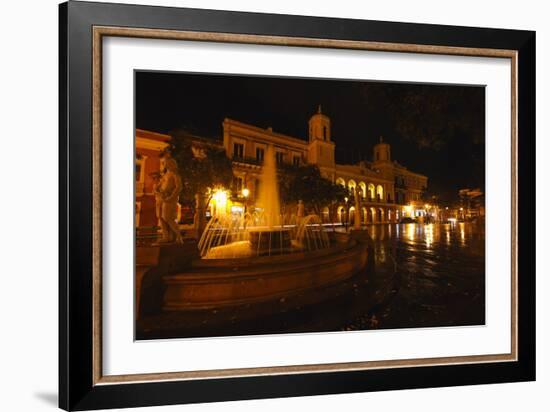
[279,164,349,216]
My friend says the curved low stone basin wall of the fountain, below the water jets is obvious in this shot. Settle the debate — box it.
[164,240,367,311]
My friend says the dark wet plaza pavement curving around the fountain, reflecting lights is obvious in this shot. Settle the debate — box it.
[136,223,485,339]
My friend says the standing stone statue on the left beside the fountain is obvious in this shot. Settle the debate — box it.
[154,157,183,244]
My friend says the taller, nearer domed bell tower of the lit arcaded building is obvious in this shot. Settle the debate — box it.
[308,105,334,168]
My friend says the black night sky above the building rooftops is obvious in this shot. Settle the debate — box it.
[136,72,485,200]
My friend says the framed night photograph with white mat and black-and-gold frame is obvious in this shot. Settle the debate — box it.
[59,1,535,410]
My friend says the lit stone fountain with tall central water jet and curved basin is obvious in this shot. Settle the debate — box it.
[164,146,367,311]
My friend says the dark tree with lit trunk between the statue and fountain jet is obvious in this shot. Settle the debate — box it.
[168,131,233,238]
